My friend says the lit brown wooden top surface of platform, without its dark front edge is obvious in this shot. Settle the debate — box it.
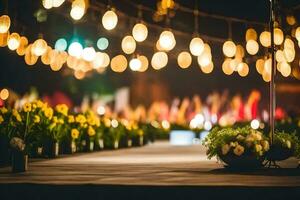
[0,142,300,187]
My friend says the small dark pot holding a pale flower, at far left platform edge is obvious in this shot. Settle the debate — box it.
[11,150,28,173]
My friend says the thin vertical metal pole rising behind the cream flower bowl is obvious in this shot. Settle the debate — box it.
[269,0,276,145]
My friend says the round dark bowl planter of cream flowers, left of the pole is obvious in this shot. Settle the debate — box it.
[204,126,270,169]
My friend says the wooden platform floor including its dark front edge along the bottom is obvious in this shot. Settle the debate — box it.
[0,142,300,199]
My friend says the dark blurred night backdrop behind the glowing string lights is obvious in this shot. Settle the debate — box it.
[0,0,300,109]
